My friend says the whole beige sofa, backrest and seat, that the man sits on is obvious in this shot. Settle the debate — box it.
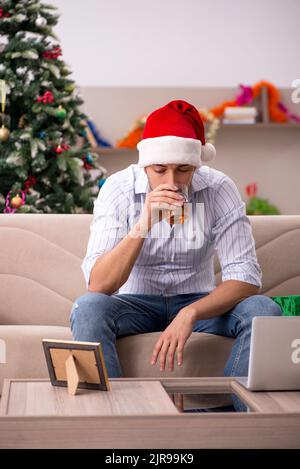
[0,214,300,392]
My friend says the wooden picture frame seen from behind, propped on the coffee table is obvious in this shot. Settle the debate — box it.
[42,339,110,395]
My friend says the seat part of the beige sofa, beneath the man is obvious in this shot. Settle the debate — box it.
[0,326,233,393]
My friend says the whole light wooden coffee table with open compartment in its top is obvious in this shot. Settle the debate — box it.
[0,378,300,448]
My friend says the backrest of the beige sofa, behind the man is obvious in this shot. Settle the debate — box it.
[0,213,300,326]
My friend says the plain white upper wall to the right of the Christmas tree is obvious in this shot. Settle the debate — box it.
[48,0,300,87]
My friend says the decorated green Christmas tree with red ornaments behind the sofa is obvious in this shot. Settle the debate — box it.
[0,0,106,213]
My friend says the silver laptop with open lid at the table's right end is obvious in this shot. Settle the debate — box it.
[237,316,300,391]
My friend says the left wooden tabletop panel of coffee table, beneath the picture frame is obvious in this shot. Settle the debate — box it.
[0,379,178,417]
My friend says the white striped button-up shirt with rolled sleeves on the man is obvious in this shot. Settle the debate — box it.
[81,164,262,296]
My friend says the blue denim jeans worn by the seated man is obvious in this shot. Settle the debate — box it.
[71,292,281,410]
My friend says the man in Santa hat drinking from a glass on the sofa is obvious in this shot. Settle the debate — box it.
[71,100,281,410]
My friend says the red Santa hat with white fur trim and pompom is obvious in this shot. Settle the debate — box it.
[137,99,216,168]
